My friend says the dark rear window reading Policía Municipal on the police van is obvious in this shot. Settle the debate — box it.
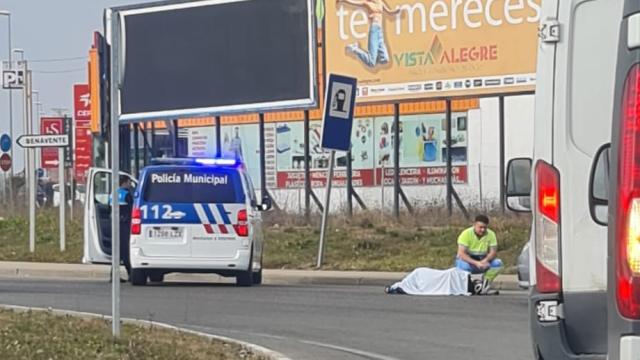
[142,168,245,204]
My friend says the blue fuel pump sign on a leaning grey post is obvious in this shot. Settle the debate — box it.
[316,74,357,268]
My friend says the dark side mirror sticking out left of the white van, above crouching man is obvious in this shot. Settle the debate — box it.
[505,158,532,212]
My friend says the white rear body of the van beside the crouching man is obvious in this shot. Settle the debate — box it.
[530,0,623,359]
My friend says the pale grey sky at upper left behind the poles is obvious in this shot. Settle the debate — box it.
[0,0,150,169]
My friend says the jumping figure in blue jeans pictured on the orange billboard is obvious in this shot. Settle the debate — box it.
[336,0,400,68]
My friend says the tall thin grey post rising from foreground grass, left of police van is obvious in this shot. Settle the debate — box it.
[110,14,123,339]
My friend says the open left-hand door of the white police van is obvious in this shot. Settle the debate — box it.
[82,168,136,264]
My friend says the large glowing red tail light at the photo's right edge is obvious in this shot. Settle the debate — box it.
[616,64,640,319]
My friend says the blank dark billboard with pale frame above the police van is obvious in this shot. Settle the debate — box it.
[112,0,317,121]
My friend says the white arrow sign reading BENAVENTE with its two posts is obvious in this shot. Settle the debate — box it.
[17,134,69,252]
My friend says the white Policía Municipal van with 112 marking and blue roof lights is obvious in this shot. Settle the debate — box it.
[84,159,271,286]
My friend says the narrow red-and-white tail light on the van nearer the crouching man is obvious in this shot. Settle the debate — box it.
[535,161,561,293]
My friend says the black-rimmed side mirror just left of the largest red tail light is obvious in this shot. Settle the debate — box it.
[589,144,611,226]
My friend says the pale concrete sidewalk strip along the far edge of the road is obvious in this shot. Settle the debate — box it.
[0,262,521,290]
